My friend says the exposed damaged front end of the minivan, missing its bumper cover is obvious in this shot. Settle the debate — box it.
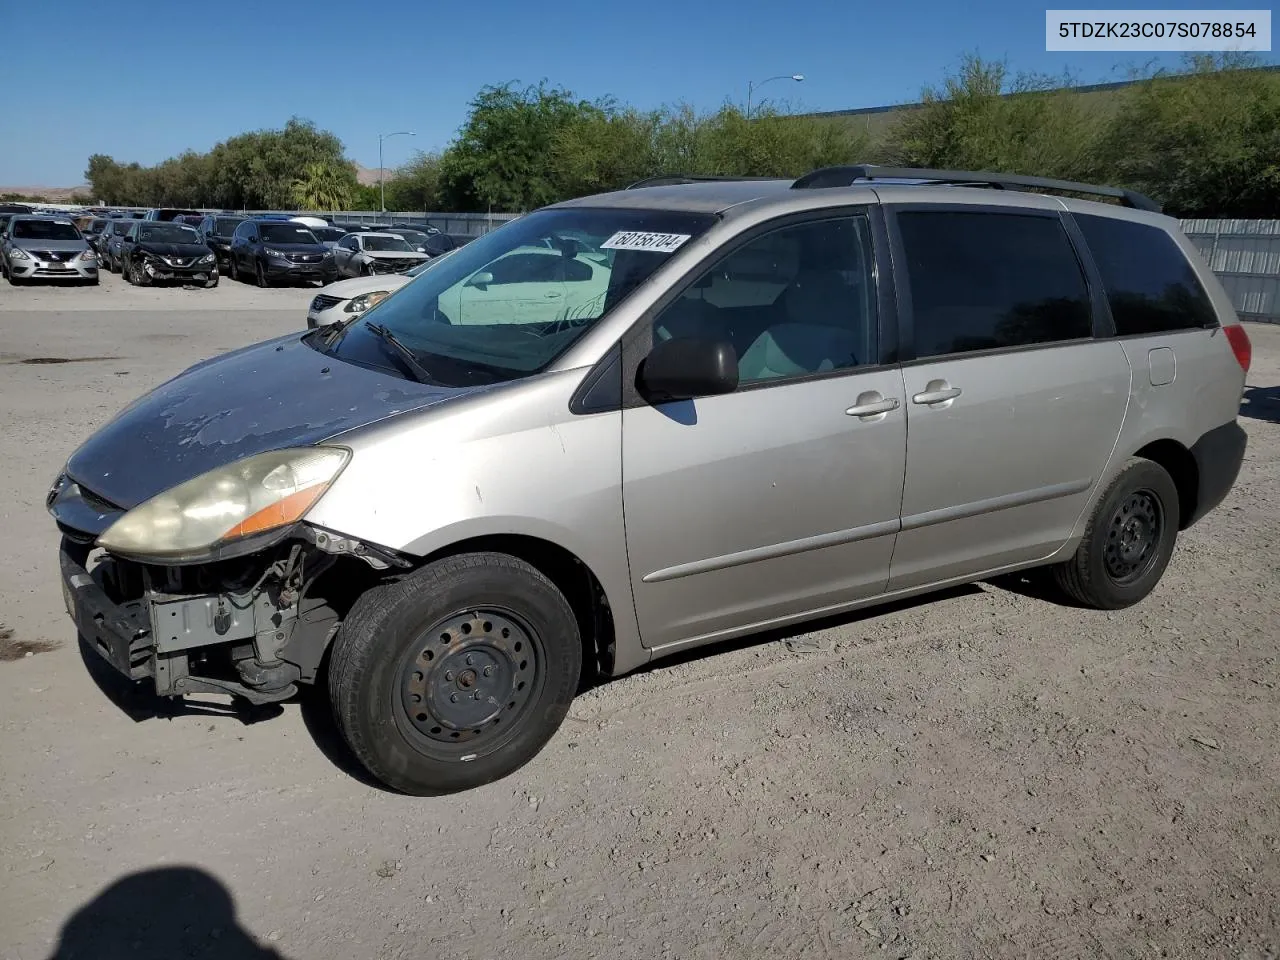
[49,477,410,704]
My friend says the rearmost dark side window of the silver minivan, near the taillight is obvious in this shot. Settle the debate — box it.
[1075,215,1217,337]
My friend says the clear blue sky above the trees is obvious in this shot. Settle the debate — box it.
[0,0,1259,186]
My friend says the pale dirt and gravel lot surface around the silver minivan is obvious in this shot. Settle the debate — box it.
[0,278,1280,960]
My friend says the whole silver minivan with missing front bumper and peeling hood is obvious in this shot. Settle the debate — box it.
[47,166,1249,794]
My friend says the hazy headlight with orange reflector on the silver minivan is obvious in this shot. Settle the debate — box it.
[97,447,351,558]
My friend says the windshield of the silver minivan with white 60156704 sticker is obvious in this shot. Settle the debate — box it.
[315,207,716,387]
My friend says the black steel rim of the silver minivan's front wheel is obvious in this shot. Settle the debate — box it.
[396,607,547,755]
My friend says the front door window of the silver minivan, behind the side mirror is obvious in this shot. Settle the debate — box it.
[654,218,876,384]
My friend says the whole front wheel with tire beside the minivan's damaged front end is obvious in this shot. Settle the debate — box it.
[329,553,582,796]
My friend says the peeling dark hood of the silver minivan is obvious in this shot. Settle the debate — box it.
[67,334,475,509]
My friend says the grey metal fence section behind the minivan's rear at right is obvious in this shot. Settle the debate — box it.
[1181,220,1280,324]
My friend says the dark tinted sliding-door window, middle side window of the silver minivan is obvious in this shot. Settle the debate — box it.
[897,211,1091,357]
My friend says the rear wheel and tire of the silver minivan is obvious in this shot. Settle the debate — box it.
[1053,457,1181,611]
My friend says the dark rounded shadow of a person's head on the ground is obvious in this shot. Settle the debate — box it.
[50,867,284,960]
